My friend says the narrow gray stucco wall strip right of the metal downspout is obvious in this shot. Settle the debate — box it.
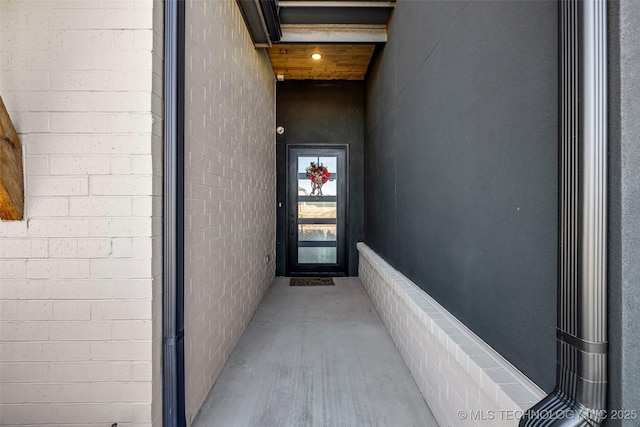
[607,0,640,426]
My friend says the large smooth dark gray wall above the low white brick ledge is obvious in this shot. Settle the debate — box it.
[365,0,558,391]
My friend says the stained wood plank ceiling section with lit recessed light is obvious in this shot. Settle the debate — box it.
[268,44,375,80]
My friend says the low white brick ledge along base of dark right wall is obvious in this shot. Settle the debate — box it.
[358,243,545,427]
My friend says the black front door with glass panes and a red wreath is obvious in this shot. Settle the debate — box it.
[287,145,348,276]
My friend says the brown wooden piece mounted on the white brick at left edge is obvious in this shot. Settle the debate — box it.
[0,96,24,220]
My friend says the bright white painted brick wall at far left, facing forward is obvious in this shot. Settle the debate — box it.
[0,0,163,426]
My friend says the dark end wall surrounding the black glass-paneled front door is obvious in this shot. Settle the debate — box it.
[276,81,364,276]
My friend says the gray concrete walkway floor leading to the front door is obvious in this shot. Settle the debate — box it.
[193,277,438,427]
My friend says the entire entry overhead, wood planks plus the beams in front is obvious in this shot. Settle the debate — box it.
[236,0,395,80]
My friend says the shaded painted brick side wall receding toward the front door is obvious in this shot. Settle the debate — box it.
[185,0,275,423]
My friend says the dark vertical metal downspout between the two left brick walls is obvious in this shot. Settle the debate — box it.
[162,0,186,427]
